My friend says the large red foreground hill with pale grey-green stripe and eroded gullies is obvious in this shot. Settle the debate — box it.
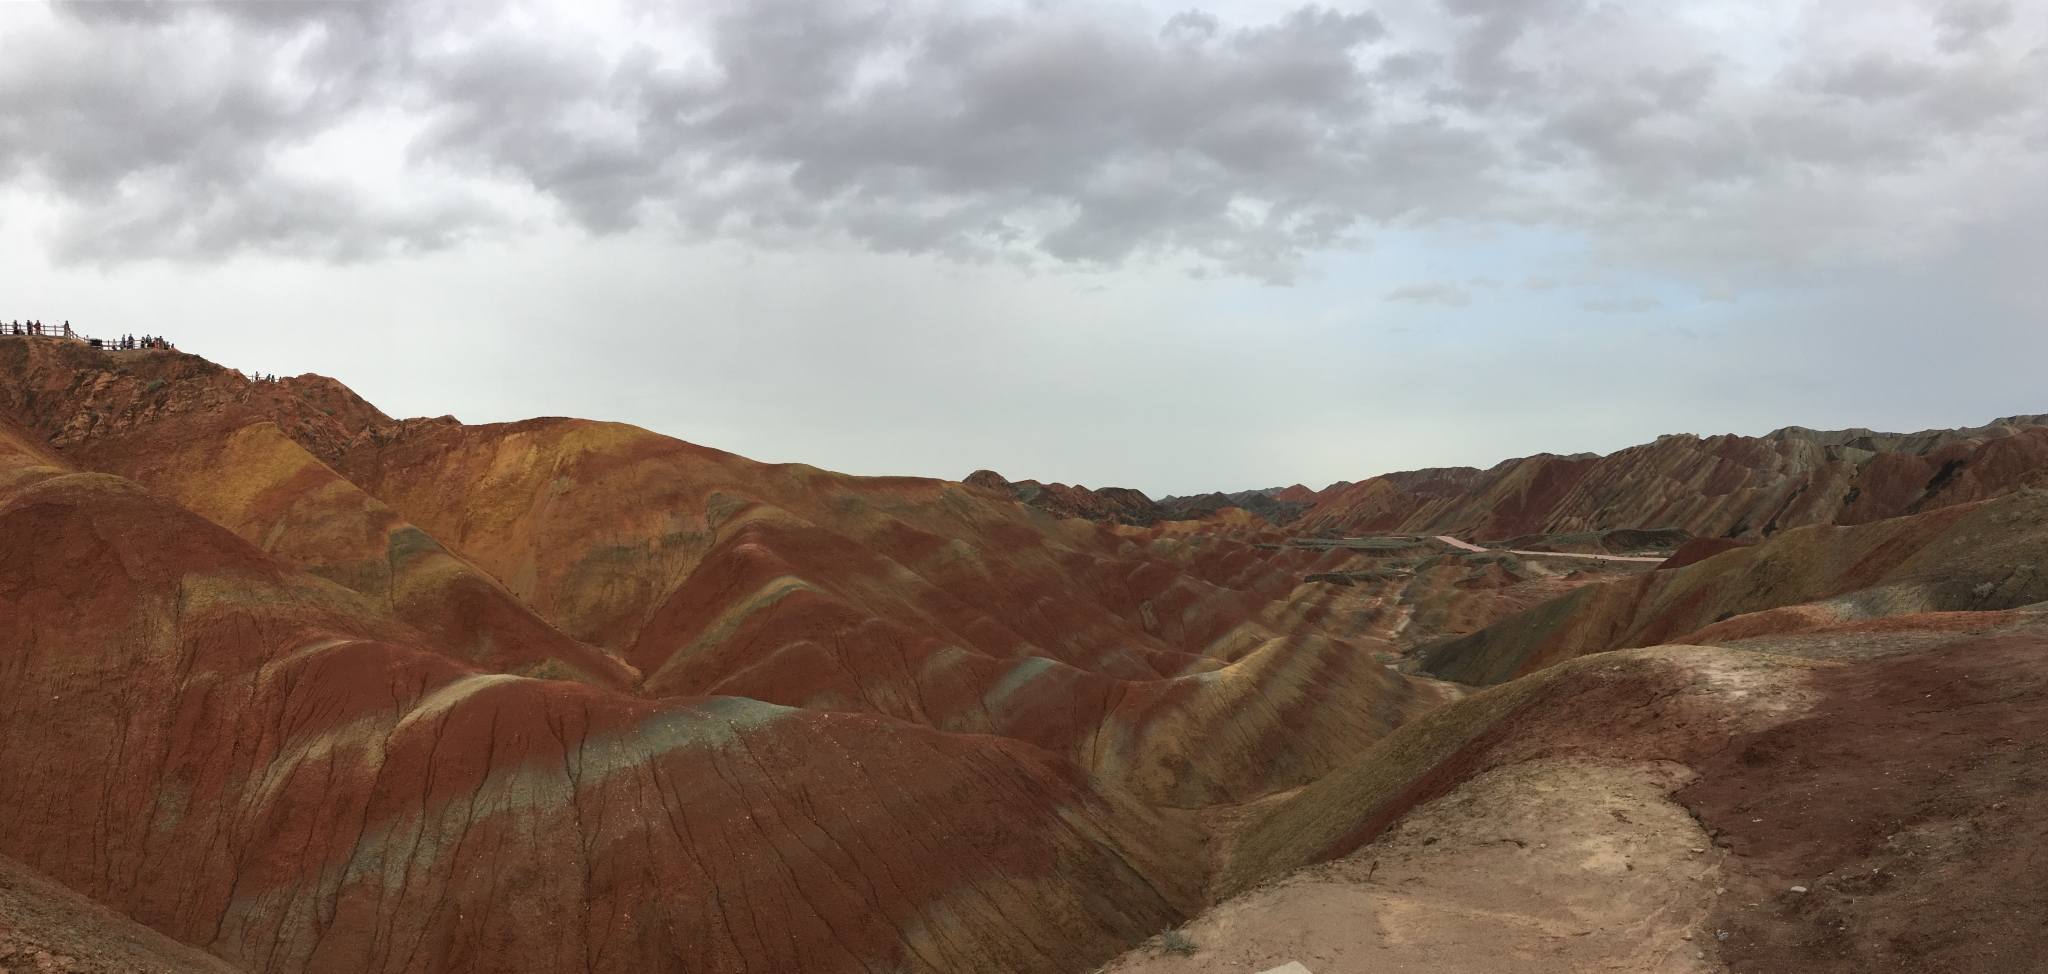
[0,475,1200,972]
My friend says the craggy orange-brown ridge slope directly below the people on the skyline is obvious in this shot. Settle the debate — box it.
[0,340,637,688]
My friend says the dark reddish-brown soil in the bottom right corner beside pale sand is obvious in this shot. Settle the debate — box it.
[1677,634,2048,974]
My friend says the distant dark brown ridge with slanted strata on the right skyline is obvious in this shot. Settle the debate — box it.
[1294,415,2048,540]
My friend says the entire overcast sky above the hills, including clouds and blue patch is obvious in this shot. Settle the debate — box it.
[0,0,2048,495]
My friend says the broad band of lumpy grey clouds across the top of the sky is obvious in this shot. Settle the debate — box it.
[0,0,2048,280]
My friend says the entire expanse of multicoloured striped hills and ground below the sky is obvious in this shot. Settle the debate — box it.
[0,336,2048,974]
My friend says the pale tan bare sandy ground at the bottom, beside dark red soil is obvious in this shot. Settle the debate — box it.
[1102,761,1724,974]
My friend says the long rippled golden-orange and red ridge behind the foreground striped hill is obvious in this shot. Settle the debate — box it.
[342,419,1436,806]
